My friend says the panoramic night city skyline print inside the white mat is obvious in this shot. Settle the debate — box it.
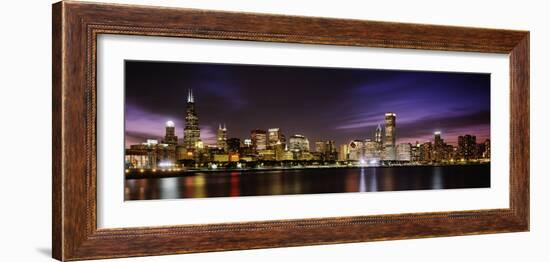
[123,60,491,201]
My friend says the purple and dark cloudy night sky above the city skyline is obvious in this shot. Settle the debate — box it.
[125,61,490,150]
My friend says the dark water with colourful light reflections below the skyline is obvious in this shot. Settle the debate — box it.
[124,164,491,200]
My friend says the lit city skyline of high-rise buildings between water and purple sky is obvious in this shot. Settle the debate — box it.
[125,89,490,169]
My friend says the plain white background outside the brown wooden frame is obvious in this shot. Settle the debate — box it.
[0,0,550,261]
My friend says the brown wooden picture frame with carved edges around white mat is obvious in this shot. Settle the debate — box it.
[52,1,529,261]
